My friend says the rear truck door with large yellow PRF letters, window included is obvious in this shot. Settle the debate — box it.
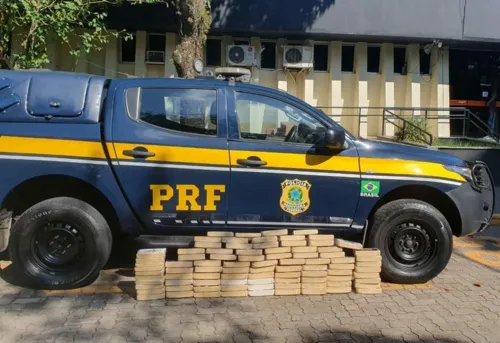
[109,79,230,234]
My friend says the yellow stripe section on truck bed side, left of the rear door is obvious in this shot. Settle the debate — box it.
[0,136,106,159]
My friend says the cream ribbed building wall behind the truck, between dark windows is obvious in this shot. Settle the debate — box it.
[17,31,449,137]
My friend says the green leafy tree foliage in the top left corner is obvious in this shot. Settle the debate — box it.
[0,0,169,69]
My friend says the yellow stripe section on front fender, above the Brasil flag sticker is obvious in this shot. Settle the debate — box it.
[360,158,466,182]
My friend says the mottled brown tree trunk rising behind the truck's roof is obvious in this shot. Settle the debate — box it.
[172,0,212,78]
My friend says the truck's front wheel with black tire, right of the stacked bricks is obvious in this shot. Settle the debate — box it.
[368,199,453,284]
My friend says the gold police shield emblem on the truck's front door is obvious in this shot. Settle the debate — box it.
[280,179,311,216]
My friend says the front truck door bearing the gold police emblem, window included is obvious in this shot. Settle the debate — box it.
[228,88,360,229]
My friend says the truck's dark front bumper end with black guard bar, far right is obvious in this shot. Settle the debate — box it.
[447,162,495,236]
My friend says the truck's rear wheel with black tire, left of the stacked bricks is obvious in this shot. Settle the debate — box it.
[9,197,112,289]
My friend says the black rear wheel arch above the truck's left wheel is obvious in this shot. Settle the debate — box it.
[0,175,120,238]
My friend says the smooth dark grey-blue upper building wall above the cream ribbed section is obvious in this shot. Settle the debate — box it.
[107,0,500,44]
